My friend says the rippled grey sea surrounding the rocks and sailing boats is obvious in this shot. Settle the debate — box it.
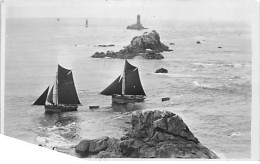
[4,18,252,159]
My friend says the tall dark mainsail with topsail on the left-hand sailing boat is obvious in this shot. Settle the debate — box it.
[57,65,80,104]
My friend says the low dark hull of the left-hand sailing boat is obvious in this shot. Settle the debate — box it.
[45,105,78,113]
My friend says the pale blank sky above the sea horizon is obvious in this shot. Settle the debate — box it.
[5,0,254,21]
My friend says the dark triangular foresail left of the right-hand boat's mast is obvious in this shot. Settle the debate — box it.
[100,76,122,95]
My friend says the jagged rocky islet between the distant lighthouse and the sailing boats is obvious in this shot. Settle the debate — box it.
[91,30,172,59]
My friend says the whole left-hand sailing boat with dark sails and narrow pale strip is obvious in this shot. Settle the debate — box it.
[33,65,81,113]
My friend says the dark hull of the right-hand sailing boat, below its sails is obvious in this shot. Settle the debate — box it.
[112,95,146,104]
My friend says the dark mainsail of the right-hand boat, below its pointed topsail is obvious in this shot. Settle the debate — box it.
[125,68,145,96]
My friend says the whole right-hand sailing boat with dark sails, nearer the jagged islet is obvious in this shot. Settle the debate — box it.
[100,60,146,104]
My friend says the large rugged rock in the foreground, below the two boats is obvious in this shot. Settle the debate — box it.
[76,110,218,159]
